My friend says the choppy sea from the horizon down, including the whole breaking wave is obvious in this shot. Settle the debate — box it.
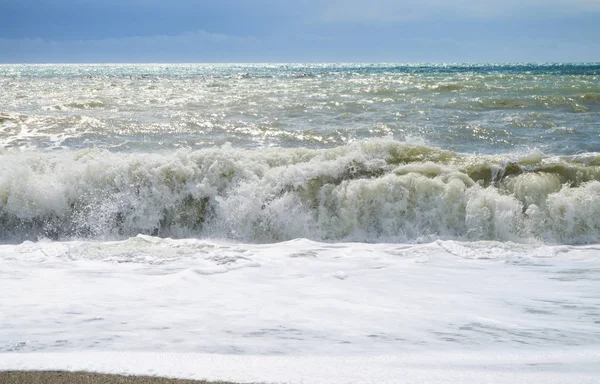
[0,64,600,244]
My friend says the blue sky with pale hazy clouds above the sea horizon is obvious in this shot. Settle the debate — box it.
[0,0,600,63]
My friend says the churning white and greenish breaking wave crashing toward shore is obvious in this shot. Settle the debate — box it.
[0,140,600,244]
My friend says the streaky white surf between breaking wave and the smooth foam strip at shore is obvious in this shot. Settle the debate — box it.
[0,235,600,356]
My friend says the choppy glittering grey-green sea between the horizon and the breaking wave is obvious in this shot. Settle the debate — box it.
[0,64,600,154]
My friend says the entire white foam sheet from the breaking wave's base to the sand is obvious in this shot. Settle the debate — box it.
[0,235,600,383]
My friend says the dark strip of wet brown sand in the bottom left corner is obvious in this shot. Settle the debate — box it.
[0,371,238,384]
